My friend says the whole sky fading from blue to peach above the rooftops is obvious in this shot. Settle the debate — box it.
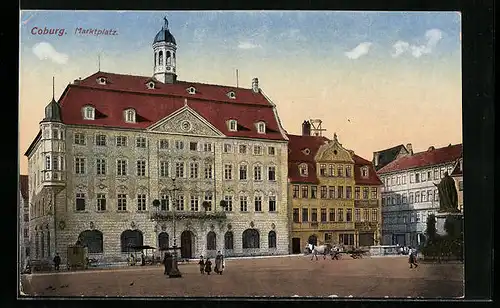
[19,11,462,174]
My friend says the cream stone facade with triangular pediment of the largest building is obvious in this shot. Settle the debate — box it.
[29,106,289,264]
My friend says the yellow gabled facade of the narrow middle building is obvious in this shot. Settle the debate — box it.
[289,136,381,253]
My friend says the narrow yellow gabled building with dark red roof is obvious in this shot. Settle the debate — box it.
[288,121,382,253]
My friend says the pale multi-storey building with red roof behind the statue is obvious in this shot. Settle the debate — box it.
[377,144,462,247]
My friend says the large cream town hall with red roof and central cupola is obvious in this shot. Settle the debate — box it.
[26,20,289,264]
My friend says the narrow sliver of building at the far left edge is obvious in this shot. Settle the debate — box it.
[19,175,30,267]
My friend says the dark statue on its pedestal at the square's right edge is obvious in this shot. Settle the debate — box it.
[434,172,463,236]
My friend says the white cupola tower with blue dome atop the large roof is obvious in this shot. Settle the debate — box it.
[153,17,177,83]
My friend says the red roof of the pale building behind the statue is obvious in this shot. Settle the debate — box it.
[378,144,462,174]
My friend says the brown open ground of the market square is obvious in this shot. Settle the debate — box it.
[23,256,463,298]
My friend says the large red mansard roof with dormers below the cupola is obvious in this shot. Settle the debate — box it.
[60,72,285,140]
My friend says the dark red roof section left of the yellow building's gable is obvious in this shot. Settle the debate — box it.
[287,135,328,184]
